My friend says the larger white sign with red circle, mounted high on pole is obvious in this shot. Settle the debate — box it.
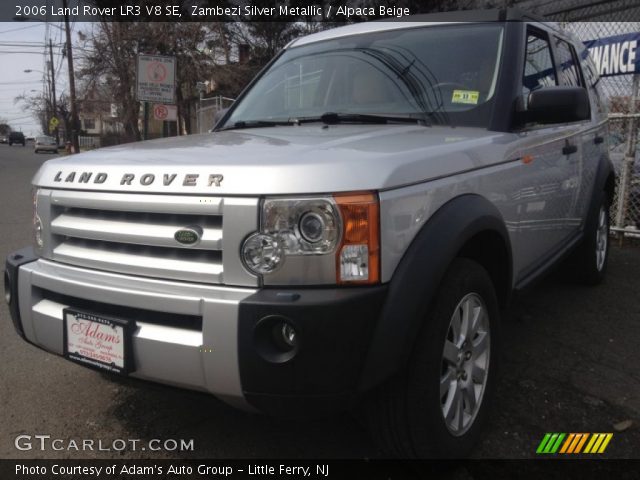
[137,55,176,103]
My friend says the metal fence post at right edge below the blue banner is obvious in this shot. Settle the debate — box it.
[615,74,640,238]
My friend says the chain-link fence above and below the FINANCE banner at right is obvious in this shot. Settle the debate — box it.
[563,21,640,237]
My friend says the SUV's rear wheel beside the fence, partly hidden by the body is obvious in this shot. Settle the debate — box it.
[565,191,610,285]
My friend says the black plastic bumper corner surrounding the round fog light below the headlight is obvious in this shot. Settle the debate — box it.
[238,286,387,415]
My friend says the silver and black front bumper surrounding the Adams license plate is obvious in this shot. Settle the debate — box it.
[5,250,386,415]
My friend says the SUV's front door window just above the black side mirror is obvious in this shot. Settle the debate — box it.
[522,31,558,98]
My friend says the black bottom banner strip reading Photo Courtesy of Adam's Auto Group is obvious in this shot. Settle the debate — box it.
[0,459,640,480]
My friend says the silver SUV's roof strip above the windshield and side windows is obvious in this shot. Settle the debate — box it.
[286,8,558,48]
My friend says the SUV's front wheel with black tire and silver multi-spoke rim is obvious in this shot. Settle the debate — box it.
[368,258,500,458]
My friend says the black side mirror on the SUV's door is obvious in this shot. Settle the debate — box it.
[527,87,590,124]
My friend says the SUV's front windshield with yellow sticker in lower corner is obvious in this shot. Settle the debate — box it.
[223,24,503,128]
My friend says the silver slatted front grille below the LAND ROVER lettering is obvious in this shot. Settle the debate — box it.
[38,190,257,285]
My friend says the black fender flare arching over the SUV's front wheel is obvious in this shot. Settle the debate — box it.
[359,194,513,391]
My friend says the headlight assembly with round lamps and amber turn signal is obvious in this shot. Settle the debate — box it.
[242,193,380,285]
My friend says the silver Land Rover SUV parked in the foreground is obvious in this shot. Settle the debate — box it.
[5,10,614,457]
